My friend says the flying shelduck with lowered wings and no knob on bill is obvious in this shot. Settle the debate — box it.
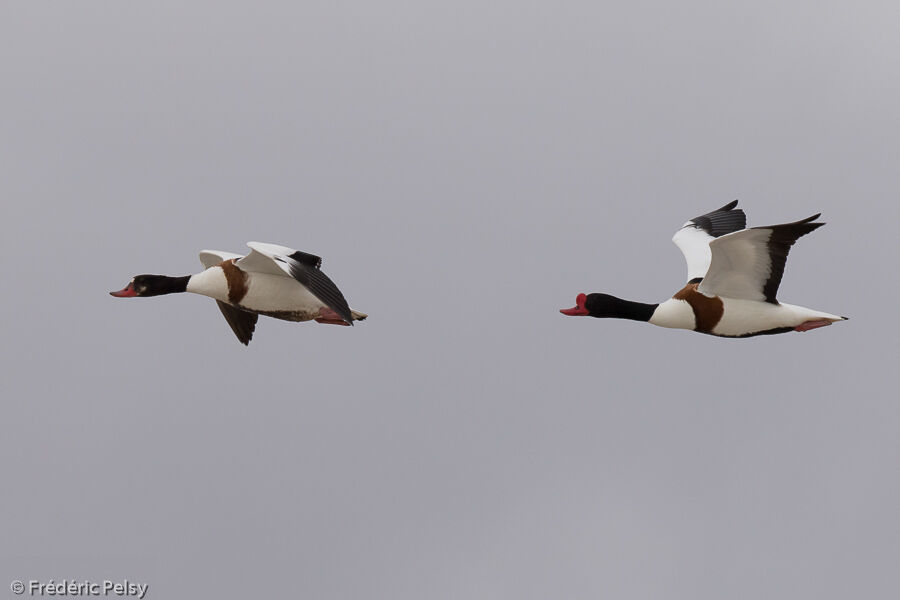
[110,242,368,345]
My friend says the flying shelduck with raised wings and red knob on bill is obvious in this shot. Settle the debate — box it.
[560,200,846,338]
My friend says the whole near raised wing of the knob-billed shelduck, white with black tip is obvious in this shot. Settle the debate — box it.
[697,215,825,304]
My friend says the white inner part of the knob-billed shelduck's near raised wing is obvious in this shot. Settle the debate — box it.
[697,228,772,301]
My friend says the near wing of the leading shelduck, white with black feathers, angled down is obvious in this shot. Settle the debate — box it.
[235,242,353,325]
